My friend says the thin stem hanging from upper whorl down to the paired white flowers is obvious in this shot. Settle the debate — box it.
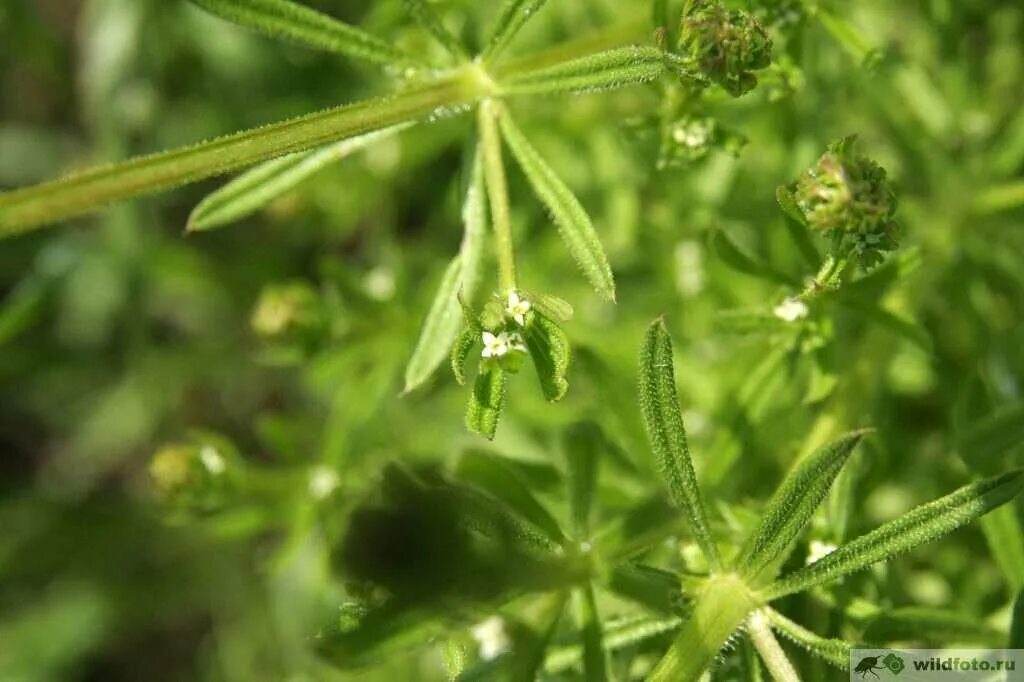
[477,99,517,294]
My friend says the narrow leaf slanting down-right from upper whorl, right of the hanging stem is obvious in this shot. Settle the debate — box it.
[500,112,615,301]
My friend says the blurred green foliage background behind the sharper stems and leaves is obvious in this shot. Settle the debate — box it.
[0,0,1024,682]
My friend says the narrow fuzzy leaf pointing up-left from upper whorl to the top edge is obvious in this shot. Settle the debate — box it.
[191,0,411,65]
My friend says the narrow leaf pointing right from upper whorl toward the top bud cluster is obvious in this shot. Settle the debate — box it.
[498,46,666,95]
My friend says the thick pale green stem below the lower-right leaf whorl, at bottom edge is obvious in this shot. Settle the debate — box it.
[647,573,760,682]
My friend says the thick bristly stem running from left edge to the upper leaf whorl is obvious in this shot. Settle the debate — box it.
[0,72,481,238]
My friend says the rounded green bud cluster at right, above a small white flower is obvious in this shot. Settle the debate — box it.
[793,135,899,267]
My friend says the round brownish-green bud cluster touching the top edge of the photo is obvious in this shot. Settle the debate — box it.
[679,0,772,97]
